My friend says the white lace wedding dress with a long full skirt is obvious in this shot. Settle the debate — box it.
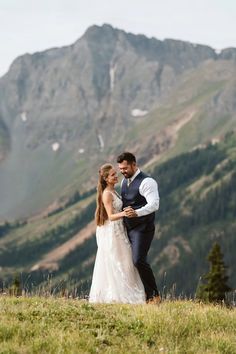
[89,193,146,304]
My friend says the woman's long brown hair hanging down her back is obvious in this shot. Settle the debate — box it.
[95,163,113,226]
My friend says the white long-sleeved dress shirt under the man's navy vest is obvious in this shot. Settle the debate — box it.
[121,168,160,216]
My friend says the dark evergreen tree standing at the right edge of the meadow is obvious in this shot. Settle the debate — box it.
[197,243,232,302]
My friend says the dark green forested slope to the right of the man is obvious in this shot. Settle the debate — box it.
[150,134,236,295]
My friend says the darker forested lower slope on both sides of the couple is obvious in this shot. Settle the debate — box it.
[0,132,236,297]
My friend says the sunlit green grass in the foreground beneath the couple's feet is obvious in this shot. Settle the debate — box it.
[0,296,236,354]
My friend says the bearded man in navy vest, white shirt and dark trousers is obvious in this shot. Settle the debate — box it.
[117,152,161,304]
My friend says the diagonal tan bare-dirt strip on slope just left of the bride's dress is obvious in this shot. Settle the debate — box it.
[31,221,96,271]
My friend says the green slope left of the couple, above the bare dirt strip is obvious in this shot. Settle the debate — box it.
[0,191,95,271]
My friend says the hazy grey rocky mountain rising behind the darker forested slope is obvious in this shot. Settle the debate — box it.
[0,25,236,221]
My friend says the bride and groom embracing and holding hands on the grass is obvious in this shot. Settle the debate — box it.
[89,152,161,304]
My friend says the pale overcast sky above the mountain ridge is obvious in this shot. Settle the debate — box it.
[0,0,236,76]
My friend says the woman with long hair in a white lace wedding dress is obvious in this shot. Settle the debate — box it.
[89,164,146,304]
